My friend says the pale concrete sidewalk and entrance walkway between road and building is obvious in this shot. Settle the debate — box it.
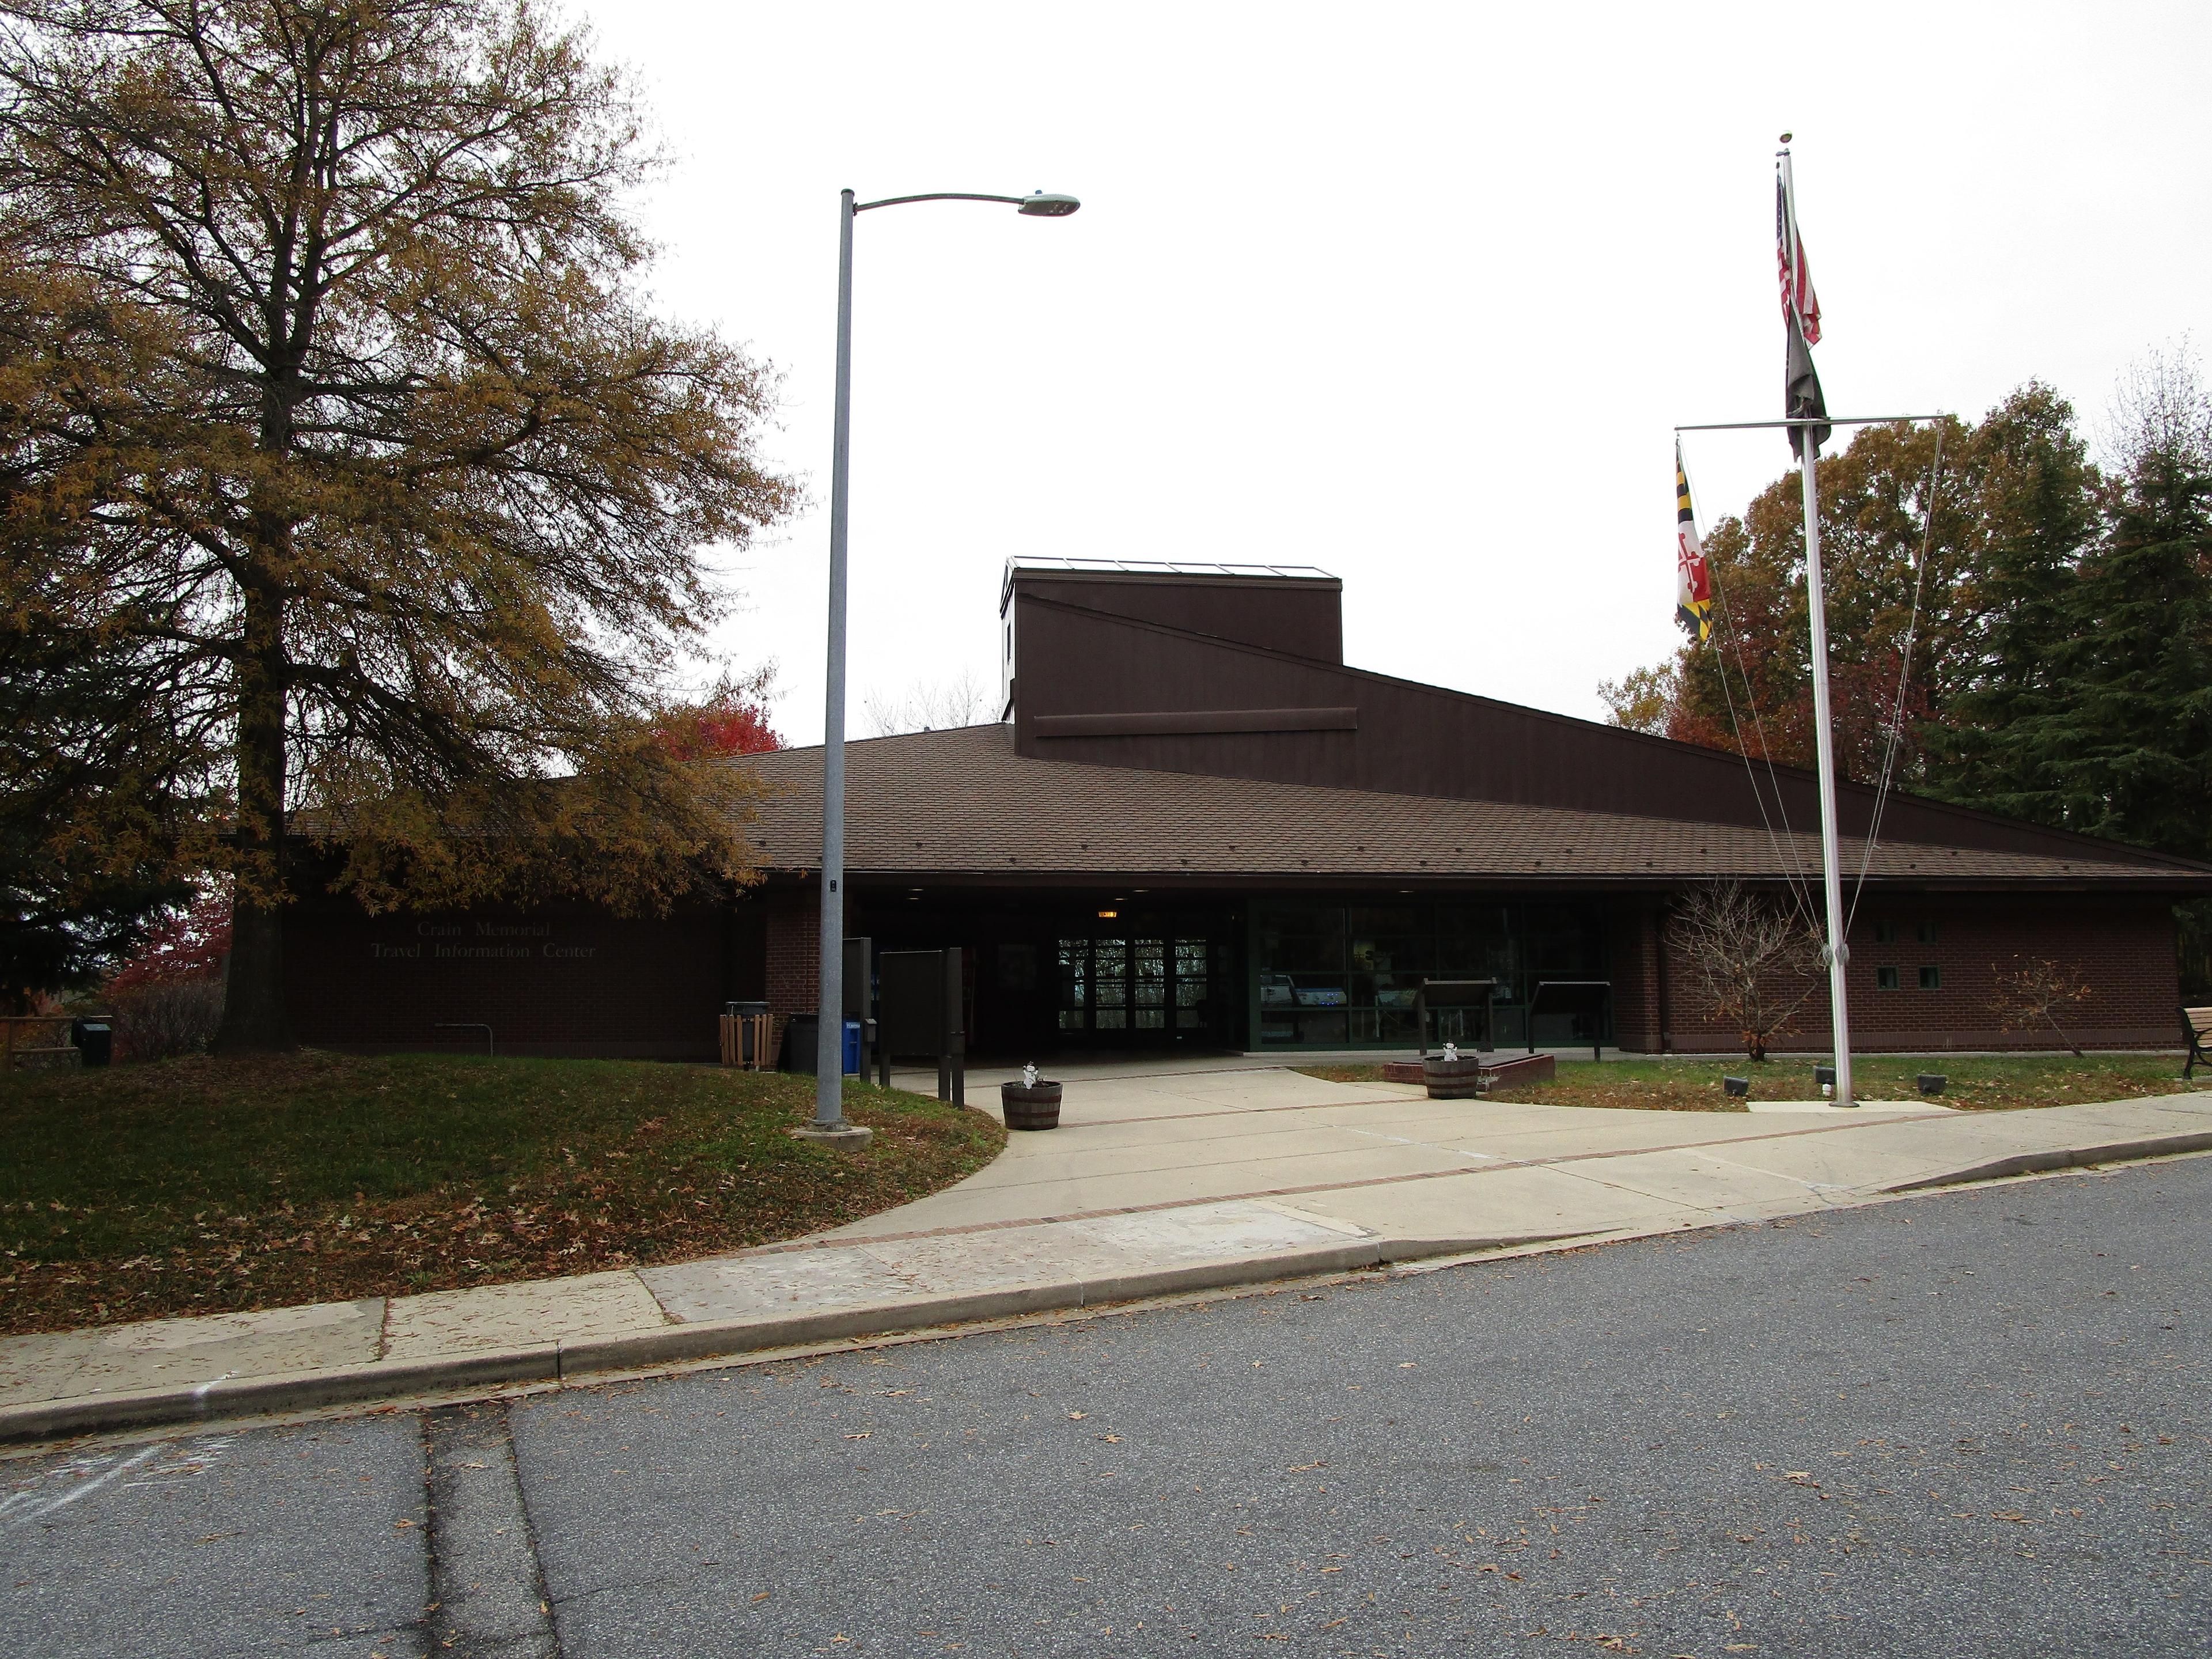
[0,1062,2212,1442]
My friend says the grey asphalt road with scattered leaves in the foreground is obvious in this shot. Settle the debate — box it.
[0,1159,2212,1659]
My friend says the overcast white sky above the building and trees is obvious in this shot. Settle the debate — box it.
[582,0,2212,743]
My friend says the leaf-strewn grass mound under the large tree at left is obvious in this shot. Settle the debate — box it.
[0,1051,1006,1334]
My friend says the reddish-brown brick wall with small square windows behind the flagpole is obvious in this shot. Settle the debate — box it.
[1666,896,2181,1053]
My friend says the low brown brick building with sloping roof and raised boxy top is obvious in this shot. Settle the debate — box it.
[285,562,2212,1058]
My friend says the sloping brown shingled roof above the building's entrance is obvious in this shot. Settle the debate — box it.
[748,726,2212,892]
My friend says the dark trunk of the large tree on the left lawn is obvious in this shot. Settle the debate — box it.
[214,582,292,1053]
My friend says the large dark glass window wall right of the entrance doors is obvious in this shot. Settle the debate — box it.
[1252,903,1611,1048]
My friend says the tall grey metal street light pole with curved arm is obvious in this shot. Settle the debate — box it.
[809,190,1082,1135]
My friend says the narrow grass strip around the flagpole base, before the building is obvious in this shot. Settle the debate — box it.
[1301,1051,2212,1113]
